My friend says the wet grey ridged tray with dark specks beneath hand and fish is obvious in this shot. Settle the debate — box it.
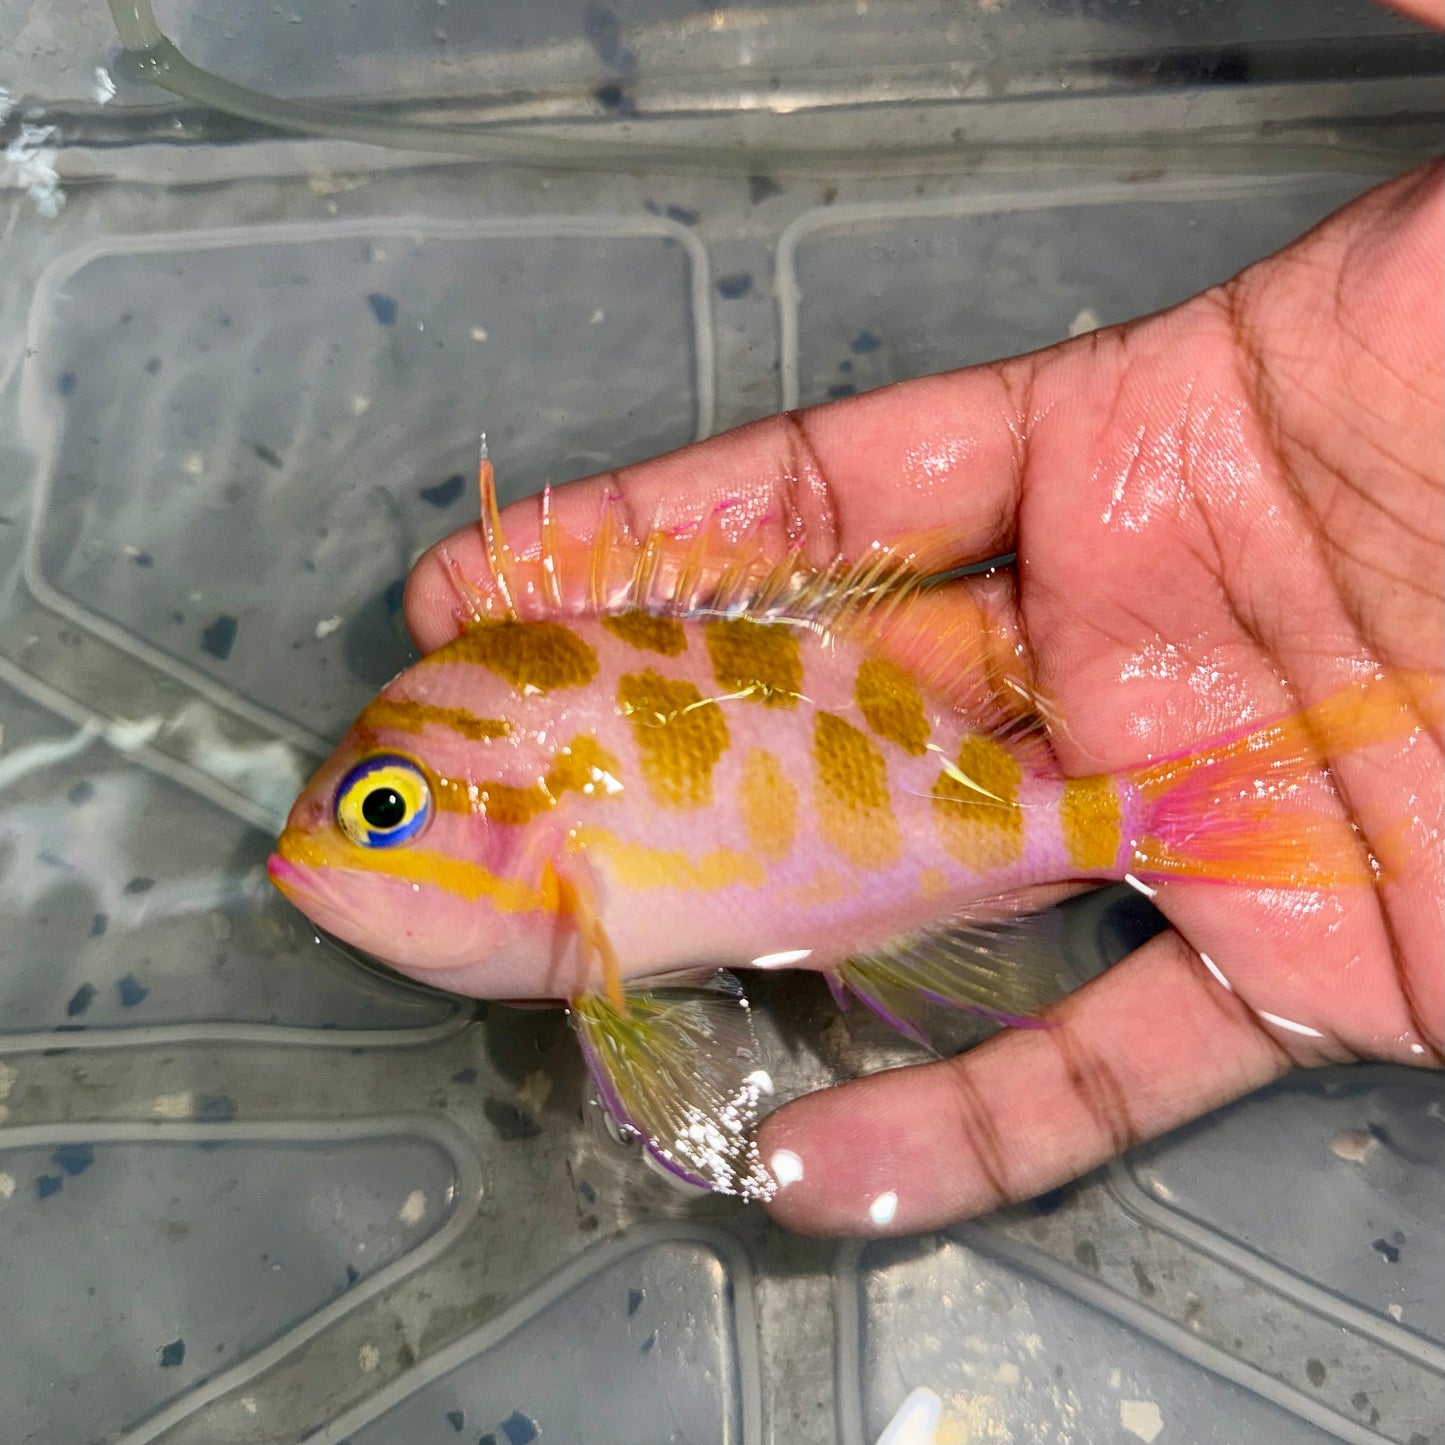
[0,6,1445,1445]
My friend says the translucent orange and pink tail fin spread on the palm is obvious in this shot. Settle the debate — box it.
[1124,672,1441,887]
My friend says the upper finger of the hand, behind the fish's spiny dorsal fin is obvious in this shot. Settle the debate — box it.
[405,361,1026,652]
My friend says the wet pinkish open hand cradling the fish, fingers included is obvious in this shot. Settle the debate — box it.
[407,166,1445,1234]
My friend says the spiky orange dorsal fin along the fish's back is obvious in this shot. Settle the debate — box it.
[456,438,1053,745]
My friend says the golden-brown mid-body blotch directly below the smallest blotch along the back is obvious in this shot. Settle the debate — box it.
[617,668,728,808]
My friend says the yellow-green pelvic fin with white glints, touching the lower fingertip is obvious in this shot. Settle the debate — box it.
[571,974,776,1199]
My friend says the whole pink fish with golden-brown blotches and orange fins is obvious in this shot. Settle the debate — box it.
[270,450,1433,1198]
